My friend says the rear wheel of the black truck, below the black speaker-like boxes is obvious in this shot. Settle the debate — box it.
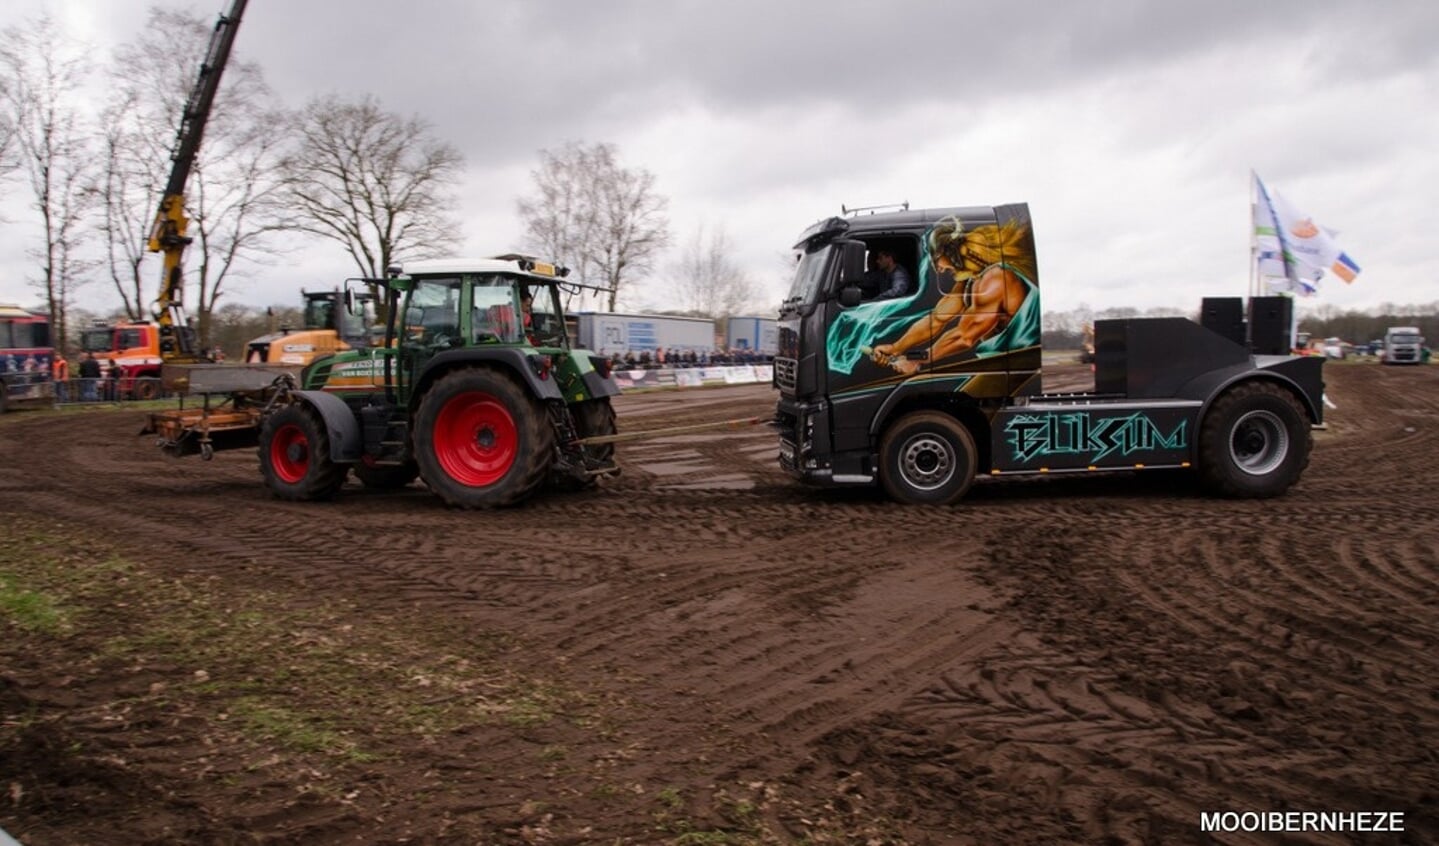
[1199,381,1314,498]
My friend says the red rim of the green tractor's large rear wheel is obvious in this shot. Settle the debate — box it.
[435,391,519,488]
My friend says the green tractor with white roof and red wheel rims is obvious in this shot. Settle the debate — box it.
[253,255,619,508]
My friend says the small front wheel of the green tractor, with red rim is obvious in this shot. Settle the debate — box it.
[259,403,348,502]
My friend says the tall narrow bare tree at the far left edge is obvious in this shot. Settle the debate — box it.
[0,16,94,353]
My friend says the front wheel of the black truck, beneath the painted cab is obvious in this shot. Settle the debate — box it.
[879,411,979,505]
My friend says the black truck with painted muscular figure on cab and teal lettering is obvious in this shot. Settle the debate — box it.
[774,204,1324,504]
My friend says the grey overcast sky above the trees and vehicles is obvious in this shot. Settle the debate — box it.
[0,0,1439,320]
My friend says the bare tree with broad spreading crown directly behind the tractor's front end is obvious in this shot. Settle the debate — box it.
[277,95,465,289]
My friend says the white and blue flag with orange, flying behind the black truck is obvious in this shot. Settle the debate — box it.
[1253,174,1360,296]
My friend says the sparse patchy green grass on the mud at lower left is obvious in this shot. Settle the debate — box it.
[0,515,596,764]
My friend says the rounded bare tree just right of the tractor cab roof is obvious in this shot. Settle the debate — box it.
[517,142,669,311]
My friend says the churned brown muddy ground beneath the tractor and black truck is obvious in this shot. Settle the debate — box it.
[0,359,1439,846]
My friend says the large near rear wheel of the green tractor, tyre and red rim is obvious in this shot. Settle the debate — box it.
[414,368,554,508]
